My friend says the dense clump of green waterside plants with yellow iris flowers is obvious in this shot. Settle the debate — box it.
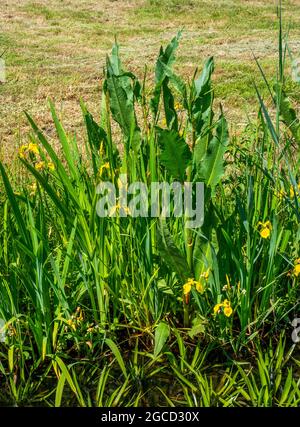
[0,8,300,406]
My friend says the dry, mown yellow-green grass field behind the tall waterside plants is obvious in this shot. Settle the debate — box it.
[0,0,300,158]
